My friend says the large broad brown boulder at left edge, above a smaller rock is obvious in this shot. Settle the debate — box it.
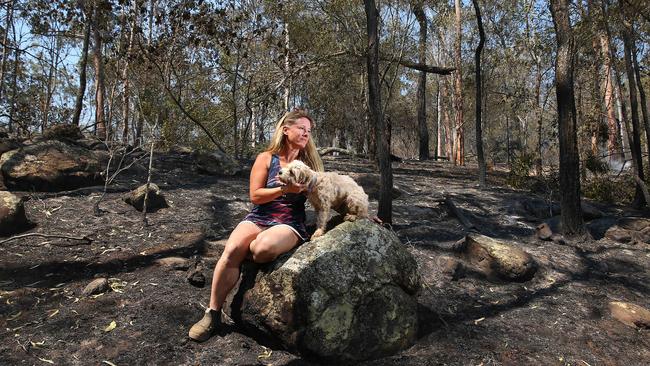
[0,140,102,191]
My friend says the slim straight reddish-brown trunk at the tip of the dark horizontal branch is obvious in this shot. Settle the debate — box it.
[454,0,465,165]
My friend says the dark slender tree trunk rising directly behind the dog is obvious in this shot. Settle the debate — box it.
[364,0,393,223]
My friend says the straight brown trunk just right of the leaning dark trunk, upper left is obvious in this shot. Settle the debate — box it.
[93,7,107,140]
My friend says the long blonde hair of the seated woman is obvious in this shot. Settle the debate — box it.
[266,109,324,172]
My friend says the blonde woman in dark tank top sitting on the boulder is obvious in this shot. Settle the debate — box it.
[189,109,323,342]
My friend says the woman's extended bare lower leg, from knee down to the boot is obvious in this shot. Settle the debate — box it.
[210,222,262,310]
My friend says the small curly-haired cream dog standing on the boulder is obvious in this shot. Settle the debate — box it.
[278,160,368,239]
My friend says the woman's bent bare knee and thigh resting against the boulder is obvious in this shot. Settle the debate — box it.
[250,225,300,263]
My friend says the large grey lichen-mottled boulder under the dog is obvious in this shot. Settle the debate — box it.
[225,219,420,363]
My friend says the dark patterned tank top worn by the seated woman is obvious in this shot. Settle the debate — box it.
[244,155,307,240]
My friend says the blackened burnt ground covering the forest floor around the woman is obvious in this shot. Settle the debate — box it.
[0,154,650,366]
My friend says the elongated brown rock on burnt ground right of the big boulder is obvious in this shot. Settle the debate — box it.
[457,234,537,282]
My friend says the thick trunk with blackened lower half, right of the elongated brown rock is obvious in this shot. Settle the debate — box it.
[550,0,584,234]
